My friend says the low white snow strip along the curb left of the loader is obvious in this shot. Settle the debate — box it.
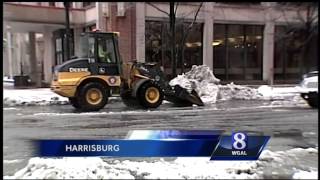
[3,88,68,106]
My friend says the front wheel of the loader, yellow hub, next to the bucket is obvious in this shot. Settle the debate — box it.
[137,82,163,108]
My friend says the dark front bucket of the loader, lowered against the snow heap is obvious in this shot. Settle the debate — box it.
[165,85,204,106]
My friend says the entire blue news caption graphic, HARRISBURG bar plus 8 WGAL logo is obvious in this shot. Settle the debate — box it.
[36,130,270,160]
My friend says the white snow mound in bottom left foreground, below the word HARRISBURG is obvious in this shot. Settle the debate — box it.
[5,157,134,179]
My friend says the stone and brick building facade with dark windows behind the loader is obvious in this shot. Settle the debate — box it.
[4,2,318,83]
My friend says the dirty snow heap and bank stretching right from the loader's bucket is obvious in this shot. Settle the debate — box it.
[169,65,305,104]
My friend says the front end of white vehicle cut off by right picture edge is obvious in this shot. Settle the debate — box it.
[299,71,318,108]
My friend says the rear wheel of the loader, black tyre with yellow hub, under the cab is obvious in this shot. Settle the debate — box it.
[78,82,108,111]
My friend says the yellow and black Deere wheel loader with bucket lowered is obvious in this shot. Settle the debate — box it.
[51,32,203,111]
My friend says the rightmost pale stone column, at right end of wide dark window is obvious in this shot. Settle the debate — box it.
[262,3,275,85]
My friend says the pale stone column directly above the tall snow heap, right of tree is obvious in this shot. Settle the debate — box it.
[203,2,214,70]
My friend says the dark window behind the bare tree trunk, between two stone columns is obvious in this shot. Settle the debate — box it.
[145,21,203,74]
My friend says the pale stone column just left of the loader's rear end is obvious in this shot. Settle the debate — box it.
[43,30,54,83]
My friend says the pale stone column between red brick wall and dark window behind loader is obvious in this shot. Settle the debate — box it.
[136,2,146,62]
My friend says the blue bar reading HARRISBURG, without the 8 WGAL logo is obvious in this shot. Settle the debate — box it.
[37,139,218,157]
